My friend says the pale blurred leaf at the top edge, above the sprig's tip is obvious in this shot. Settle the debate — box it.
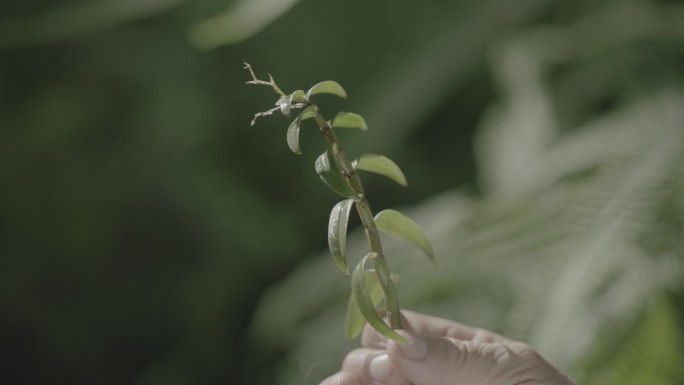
[190,0,299,49]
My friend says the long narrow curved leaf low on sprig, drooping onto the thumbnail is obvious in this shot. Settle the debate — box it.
[352,253,409,343]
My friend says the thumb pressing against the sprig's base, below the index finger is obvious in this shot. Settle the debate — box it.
[387,331,571,385]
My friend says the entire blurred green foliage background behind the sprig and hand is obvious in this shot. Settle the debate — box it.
[0,0,684,385]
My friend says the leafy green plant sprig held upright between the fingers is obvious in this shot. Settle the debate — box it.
[245,63,435,343]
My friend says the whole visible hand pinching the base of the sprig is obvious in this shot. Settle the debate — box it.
[321,311,573,385]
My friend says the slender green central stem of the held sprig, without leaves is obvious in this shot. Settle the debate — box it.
[307,112,402,329]
